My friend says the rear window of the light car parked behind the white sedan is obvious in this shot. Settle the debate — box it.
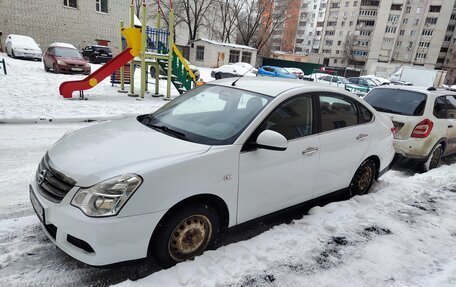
[364,88,427,116]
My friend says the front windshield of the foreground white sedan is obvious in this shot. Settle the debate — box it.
[138,85,272,145]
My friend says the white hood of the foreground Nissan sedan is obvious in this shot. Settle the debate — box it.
[48,118,211,187]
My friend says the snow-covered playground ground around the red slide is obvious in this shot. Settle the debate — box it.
[0,53,213,123]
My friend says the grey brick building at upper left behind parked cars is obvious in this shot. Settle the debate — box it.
[0,0,130,53]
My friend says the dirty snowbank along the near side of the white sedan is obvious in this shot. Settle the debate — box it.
[116,165,456,287]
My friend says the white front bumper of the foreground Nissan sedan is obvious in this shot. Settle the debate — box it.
[30,181,166,266]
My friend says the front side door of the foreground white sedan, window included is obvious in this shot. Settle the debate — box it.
[237,95,320,223]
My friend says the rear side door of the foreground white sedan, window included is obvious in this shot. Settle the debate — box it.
[315,92,373,197]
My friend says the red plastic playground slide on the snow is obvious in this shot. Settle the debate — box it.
[59,48,133,98]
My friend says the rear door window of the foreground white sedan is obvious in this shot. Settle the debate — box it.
[320,94,358,132]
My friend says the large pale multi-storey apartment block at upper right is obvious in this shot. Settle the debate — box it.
[311,0,456,76]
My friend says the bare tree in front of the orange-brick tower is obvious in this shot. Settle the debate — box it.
[237,0,290,55]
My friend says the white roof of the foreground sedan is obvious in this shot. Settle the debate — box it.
[207,77,350,97]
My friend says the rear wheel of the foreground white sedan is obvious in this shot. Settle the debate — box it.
[348,159,376,196]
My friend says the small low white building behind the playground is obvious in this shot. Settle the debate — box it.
[189,39,257,68]
